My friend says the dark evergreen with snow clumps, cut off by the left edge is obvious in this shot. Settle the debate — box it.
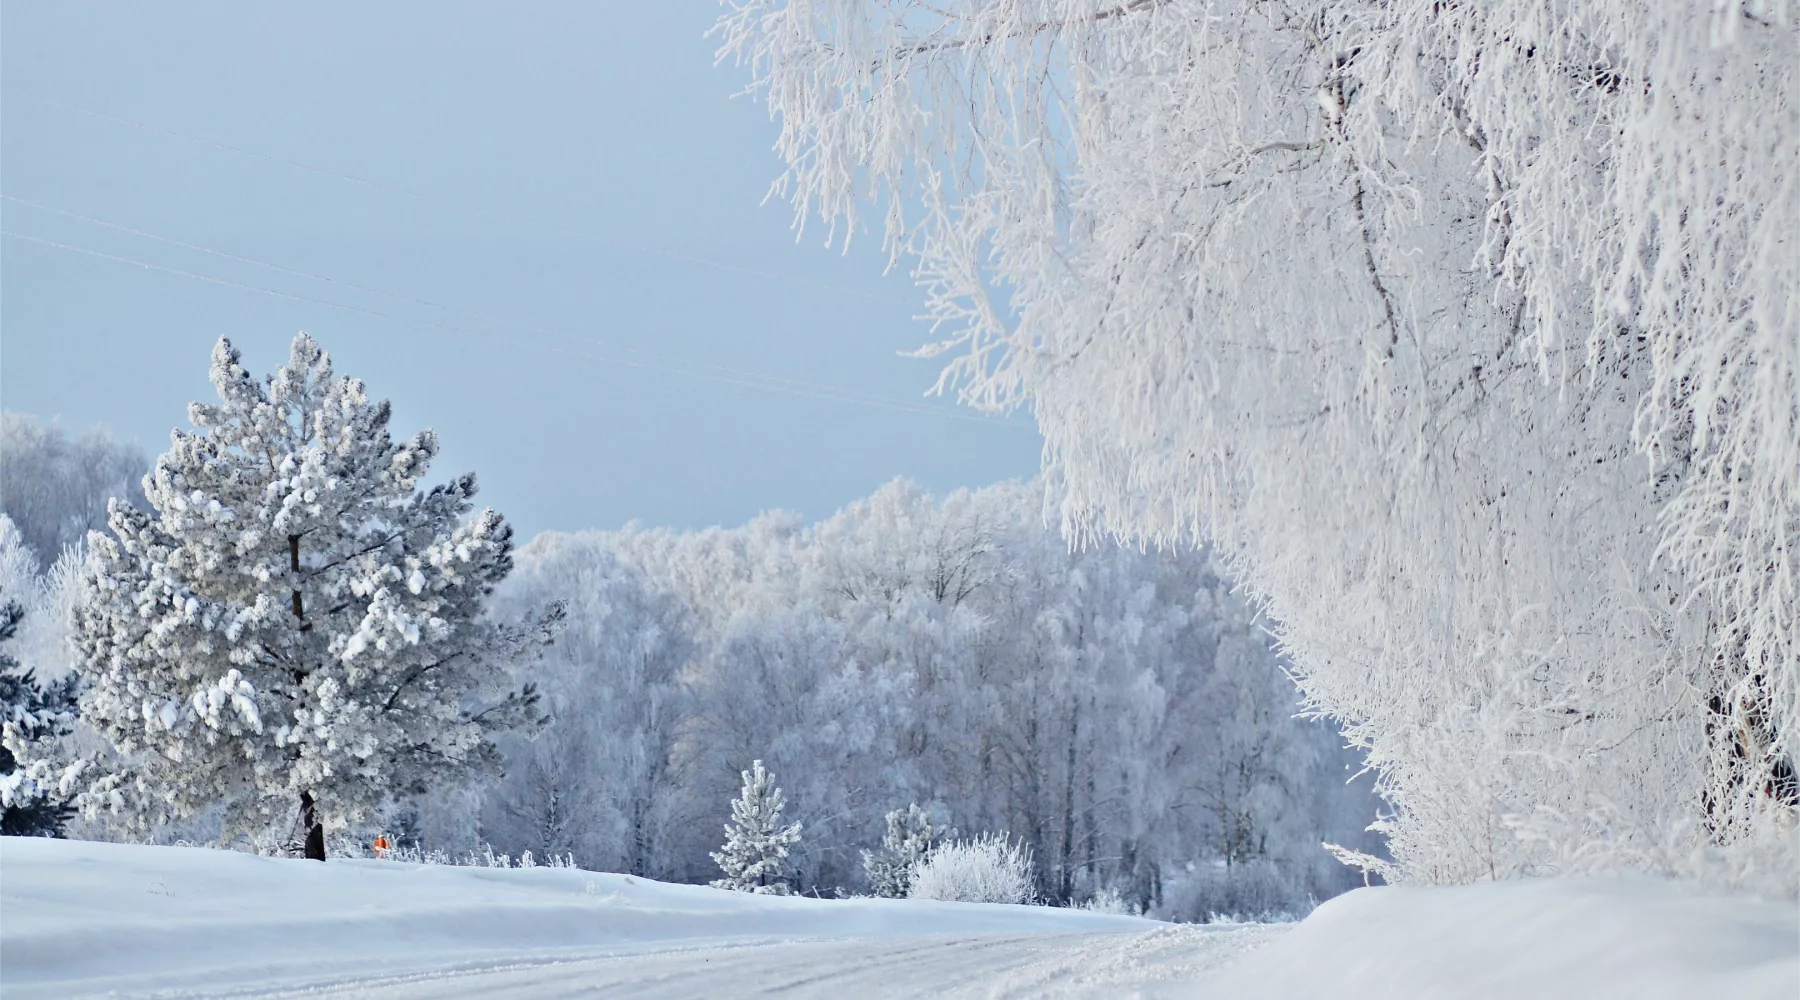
[0,589,77,836]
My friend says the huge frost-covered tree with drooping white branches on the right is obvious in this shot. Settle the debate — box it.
[718,0,1800,892]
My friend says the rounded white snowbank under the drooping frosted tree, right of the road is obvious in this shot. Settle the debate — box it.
[1202,876,1800,1000]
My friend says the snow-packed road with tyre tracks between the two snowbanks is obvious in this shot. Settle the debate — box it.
[223,924,1285,1000]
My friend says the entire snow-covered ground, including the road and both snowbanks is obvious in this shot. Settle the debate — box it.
[0,838,1800,1000]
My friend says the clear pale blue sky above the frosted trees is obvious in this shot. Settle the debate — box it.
[0,0,1040,534]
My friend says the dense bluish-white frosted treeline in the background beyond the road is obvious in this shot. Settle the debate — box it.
[450,482,1373,915]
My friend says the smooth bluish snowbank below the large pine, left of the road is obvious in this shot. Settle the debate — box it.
[0,836,1165,1000]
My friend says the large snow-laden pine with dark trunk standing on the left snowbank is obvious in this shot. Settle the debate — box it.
[74,333,562,860]
